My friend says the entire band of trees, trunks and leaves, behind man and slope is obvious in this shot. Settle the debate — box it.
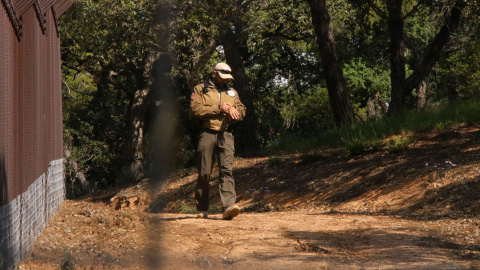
[60,0,480,195]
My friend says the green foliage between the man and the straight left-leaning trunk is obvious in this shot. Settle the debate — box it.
[244,0,322,140]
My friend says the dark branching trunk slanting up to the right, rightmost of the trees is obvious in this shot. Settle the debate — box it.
[388,0,466,115]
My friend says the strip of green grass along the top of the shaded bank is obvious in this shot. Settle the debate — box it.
[266,101,480,156]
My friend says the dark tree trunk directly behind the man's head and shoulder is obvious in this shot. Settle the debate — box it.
[220,26,260,152]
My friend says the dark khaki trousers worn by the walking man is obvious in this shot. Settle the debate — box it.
[195,130,236,211]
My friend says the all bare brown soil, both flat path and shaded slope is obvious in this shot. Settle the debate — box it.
[19,124,480,270]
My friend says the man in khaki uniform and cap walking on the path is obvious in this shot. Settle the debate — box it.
[190,63,245,220]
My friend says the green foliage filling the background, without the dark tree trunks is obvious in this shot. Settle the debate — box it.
[60,0,480,196]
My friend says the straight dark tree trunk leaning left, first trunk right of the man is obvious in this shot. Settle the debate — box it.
[308,0,354,126]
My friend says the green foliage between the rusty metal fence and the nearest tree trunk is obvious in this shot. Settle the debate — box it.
[60,0,159,192]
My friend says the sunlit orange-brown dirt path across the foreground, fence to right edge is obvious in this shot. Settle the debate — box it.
[20,201,480,270]
